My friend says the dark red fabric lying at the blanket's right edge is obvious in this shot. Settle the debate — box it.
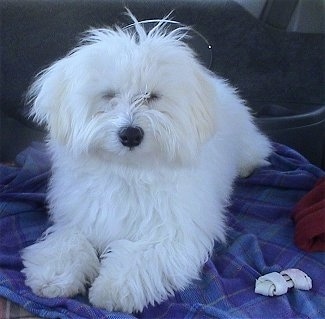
[292,177,325,251]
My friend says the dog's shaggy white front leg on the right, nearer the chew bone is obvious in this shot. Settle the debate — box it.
[89,238,208,313]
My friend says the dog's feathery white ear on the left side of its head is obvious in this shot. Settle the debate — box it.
[27,58,71,144]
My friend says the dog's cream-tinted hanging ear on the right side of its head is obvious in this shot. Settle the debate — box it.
[191,65,216,142]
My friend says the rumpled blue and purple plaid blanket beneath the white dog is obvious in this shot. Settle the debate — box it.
[0,144,325,319]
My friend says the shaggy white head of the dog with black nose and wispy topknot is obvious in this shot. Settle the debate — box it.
[29,14,216,168]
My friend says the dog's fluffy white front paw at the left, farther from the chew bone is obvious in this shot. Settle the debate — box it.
[22,229,99,298]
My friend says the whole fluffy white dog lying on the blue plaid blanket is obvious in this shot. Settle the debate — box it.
[22,14,271,312]
